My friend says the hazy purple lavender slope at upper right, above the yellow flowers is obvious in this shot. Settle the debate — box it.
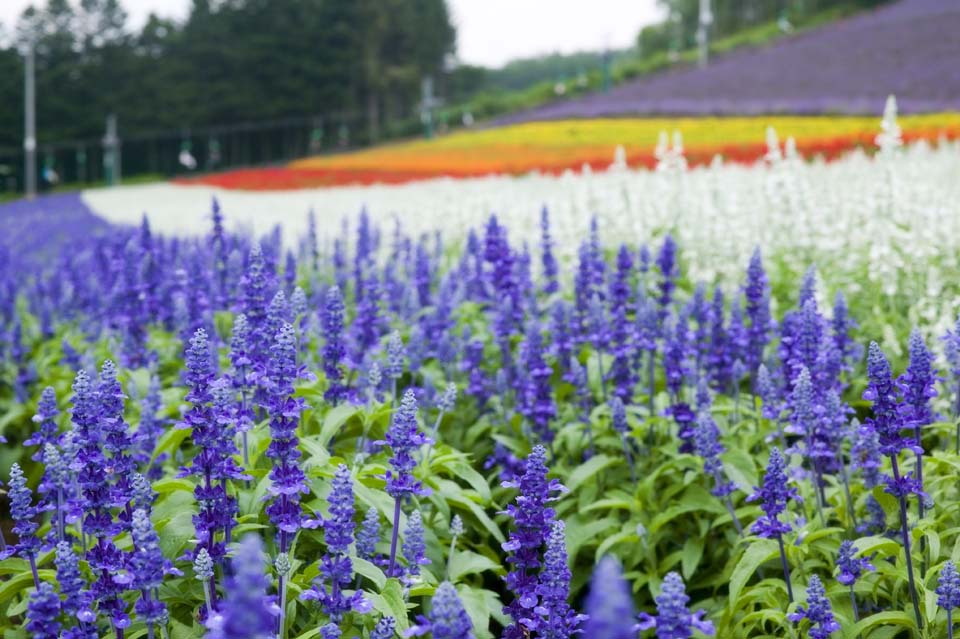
[496,0,960,124]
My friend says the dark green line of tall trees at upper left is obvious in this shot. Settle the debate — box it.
[0,0,455,147]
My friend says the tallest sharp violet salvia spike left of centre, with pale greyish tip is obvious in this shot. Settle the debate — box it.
[266,324,316,553]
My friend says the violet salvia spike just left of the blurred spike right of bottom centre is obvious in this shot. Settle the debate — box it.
[534,521,584,639]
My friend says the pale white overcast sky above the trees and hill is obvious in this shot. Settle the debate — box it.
[0,0,660,66]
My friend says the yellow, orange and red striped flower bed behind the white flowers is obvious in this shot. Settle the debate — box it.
[177,114,960,191]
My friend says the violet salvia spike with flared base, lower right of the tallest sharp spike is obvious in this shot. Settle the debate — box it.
[300,464,370,624]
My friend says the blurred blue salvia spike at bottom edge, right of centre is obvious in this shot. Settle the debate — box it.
[583,555,637,639]
